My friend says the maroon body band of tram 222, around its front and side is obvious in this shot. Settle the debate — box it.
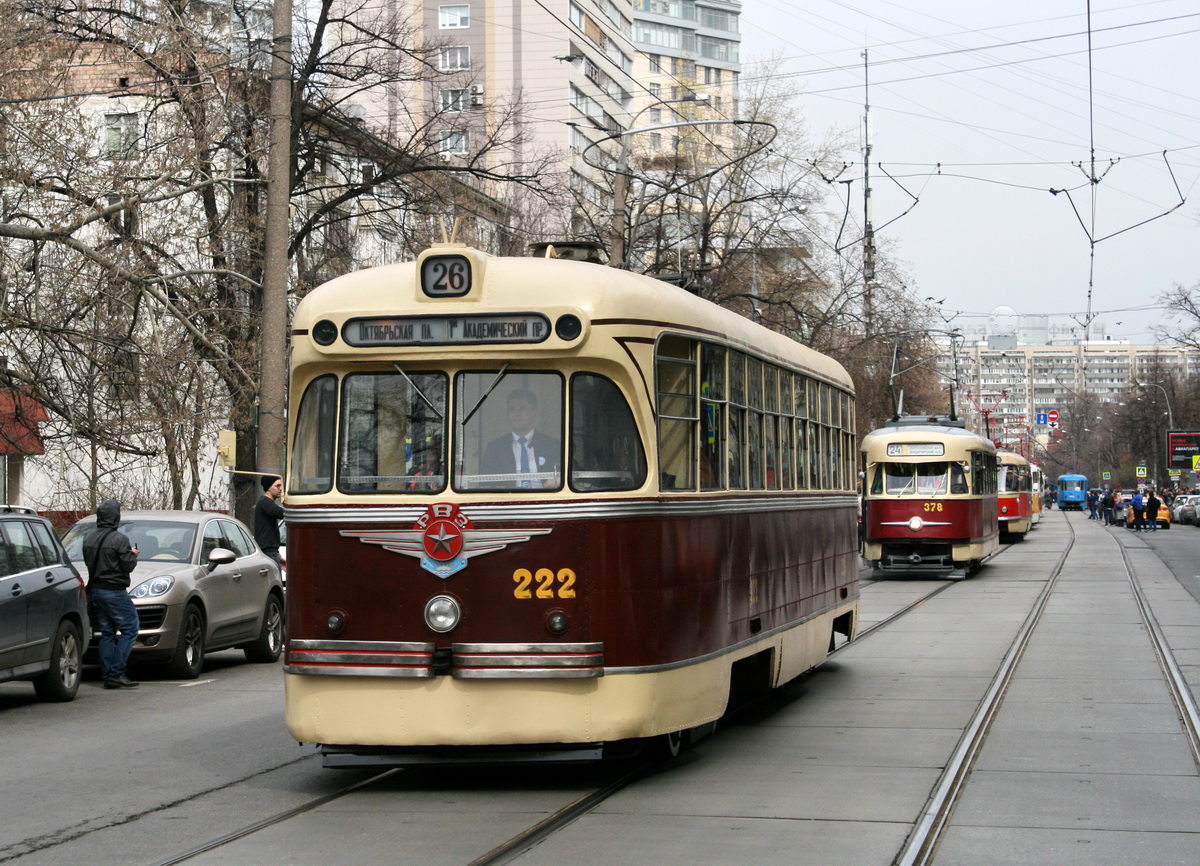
[288,498,858,667]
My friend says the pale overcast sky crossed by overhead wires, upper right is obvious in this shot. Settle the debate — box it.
[742,0,1200,342]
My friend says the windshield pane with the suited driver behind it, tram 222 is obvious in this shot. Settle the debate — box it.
[454,369,563,492]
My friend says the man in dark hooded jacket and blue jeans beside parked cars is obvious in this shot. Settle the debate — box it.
[83,499,138,688]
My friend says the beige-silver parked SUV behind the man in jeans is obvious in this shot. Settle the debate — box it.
[62,511,283,679]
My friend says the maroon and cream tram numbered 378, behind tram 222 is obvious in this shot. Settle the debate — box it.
[862,416,1000,575]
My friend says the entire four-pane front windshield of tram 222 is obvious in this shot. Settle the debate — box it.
[289,366,647,494]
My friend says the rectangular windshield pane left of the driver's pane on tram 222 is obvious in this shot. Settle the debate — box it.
[338,372,449,493]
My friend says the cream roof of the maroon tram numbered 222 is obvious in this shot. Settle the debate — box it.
[293,243,853,391]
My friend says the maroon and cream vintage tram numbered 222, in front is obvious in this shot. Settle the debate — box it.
[283,236,859,766]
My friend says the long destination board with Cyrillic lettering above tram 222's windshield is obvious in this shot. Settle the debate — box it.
[342,313,550,348]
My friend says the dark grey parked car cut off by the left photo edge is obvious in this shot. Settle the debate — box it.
[0,505,91,700]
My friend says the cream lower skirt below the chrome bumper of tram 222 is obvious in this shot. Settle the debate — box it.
[283,603,854,746]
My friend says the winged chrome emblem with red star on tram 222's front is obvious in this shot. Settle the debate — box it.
[338,503,552,579]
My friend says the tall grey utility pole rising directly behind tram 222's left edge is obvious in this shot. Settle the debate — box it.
[256,0,292,475]
